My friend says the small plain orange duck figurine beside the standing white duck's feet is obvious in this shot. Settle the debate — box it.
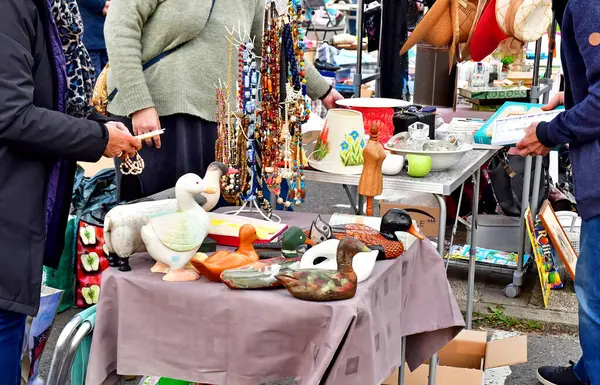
[192,224,258,282]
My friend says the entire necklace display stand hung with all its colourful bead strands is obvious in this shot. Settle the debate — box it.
[215,0,310,222]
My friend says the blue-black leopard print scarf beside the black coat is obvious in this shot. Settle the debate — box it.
[51,0,94,118]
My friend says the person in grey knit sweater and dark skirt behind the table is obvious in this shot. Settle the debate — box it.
[104,0,342,200]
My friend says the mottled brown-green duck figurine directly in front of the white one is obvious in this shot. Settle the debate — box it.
[275,237,370,301]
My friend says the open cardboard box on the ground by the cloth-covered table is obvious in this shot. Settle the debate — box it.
[382,330,527,385]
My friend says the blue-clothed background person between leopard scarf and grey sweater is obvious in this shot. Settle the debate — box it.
[77,0,110,77]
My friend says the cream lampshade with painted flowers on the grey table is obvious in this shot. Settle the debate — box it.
[308,108,366,175]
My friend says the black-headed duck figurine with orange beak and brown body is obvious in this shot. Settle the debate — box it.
[332,208,425,260]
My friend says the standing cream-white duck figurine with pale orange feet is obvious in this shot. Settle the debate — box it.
[142,174,214,282]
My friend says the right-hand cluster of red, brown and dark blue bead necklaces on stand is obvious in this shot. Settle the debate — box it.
[261,0,310,207]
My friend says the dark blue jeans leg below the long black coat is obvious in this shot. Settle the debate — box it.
[0,309,26,385]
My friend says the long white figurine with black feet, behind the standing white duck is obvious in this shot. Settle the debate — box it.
[104,162,228,271]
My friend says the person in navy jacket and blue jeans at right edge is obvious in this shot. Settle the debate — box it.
[517,0,600,385]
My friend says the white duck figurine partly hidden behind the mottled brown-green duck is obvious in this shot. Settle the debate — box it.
[300,239,379,282]
